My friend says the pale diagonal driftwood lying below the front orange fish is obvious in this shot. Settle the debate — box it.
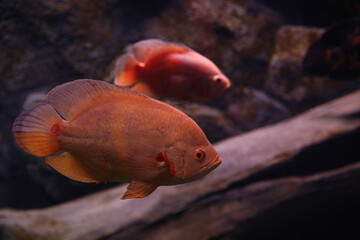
[0,91,360,240]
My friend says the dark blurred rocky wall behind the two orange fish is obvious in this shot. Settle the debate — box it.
[0,0,360,238]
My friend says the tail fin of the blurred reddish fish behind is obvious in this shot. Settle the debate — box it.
[114,53,143,87]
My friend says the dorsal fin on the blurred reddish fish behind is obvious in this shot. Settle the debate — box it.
[126,39,192,63]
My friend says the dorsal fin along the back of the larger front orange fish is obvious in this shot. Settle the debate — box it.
[46,79,146,120]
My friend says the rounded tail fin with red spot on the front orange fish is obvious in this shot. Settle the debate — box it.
[12,103,63,157]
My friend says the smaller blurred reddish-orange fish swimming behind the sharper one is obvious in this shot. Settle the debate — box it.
[114,39,231,100]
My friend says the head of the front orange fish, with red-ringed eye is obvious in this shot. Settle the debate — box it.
[167,118,221,183]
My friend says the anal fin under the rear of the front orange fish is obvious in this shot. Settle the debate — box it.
[46,152,106,182]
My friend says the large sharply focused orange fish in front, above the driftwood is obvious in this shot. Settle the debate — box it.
[13,80,221,199]
